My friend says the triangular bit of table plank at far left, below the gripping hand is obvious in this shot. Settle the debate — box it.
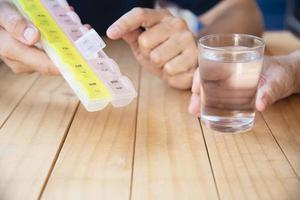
[0,63,38,128]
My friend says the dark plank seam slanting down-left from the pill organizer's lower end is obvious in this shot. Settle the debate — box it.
[38,102,80,199]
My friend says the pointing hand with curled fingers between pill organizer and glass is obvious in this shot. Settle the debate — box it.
[107,8,197,89]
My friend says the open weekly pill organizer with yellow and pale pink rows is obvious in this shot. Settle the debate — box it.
[13,0,137,112]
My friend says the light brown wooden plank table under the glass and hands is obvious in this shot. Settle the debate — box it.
[0,32,300,200]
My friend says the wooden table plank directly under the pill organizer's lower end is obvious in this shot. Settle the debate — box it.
[42,39,139,200]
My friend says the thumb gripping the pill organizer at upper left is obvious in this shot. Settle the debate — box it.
[0,2,40,45]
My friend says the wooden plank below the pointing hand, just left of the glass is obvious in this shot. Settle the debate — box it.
[132,70,217,200]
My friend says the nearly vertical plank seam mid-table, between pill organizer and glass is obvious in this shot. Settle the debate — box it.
[129,66,142,200]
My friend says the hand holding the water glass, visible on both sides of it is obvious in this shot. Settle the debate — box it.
[189,51,300,116]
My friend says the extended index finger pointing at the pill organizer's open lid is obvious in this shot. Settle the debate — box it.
[107,8,170,39]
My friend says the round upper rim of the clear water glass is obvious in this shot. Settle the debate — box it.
[198,33,266,52]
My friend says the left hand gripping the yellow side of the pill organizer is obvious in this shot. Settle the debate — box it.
[0,1,59,75]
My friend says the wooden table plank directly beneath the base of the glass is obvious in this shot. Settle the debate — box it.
[203,114,300,200]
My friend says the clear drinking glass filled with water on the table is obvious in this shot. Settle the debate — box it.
[199,34,265,133]
